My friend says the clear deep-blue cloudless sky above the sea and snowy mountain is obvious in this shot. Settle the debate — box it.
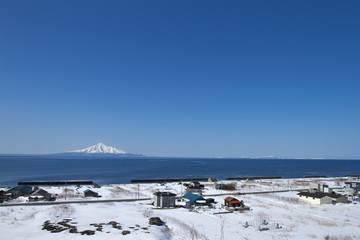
[0,0,360,159]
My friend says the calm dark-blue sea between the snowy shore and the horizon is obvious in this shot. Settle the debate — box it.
[0,155,360,186]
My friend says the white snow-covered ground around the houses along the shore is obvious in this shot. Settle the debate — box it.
[0,178,360,240]
